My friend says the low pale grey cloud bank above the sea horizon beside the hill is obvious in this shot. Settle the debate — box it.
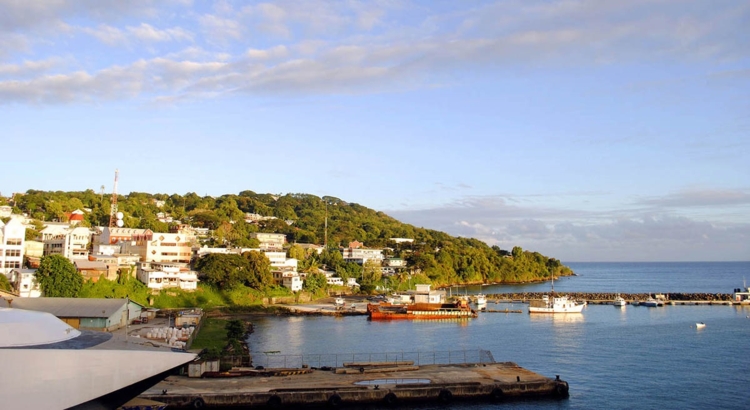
[386,190,750,261]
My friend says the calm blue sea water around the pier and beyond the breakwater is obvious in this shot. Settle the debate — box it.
[249,263,750,410]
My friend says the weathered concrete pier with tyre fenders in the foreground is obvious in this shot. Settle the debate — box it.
[139,362,568,408]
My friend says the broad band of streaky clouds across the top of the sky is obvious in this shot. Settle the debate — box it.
[0,0,750,104]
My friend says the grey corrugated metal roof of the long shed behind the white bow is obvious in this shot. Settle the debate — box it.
[8,298,140,318]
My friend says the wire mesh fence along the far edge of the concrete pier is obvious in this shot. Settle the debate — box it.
[253,349,495,369]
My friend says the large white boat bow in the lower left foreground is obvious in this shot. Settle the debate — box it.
[0,308,195,409]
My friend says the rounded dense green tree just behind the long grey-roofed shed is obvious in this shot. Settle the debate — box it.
[36,255,83,298]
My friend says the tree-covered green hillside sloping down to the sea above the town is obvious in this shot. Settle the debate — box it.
[4,190,572,286]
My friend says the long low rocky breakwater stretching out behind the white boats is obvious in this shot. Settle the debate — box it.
[487,292,732,302]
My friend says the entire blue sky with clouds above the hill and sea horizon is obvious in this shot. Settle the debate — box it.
[0,0,750,261]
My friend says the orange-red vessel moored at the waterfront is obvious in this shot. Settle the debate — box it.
[367,299,477,320]
